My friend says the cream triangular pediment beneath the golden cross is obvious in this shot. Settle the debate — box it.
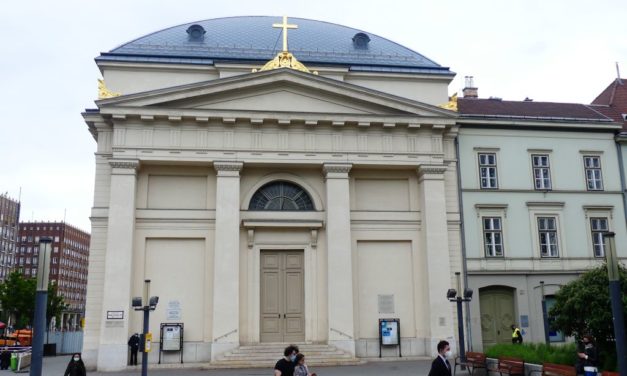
[97,69,455,118]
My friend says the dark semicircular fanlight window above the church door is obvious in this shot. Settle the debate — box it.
[248,180,315,211]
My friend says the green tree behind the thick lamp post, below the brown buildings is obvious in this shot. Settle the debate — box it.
[0,271,67,329]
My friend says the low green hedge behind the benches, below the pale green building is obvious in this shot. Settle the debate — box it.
[486,343,577,366]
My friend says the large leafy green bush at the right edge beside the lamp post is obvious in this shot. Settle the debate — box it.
[549,265,627,370]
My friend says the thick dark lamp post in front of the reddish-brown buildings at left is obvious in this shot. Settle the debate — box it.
[30,238,52,376]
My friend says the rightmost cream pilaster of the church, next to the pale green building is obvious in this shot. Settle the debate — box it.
[418,165,457,355]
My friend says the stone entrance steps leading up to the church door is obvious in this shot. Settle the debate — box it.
[210,343,365,369]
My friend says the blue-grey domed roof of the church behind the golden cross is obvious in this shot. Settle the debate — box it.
[96,16,453,75]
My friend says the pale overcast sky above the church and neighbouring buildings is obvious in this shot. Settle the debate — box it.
[0,0,627,231]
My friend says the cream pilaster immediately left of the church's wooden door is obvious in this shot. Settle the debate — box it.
[211,161,243,360]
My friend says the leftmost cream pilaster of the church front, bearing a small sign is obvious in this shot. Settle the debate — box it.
[96,160,139,371]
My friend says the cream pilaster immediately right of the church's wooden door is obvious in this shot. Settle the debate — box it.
[323,163,355,355]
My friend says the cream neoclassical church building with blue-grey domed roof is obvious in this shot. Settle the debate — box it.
[83,17,462,370]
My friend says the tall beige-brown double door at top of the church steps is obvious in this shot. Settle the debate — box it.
[260,250,305,342]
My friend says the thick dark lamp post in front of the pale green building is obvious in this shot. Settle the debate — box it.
[603,232,627,376]
